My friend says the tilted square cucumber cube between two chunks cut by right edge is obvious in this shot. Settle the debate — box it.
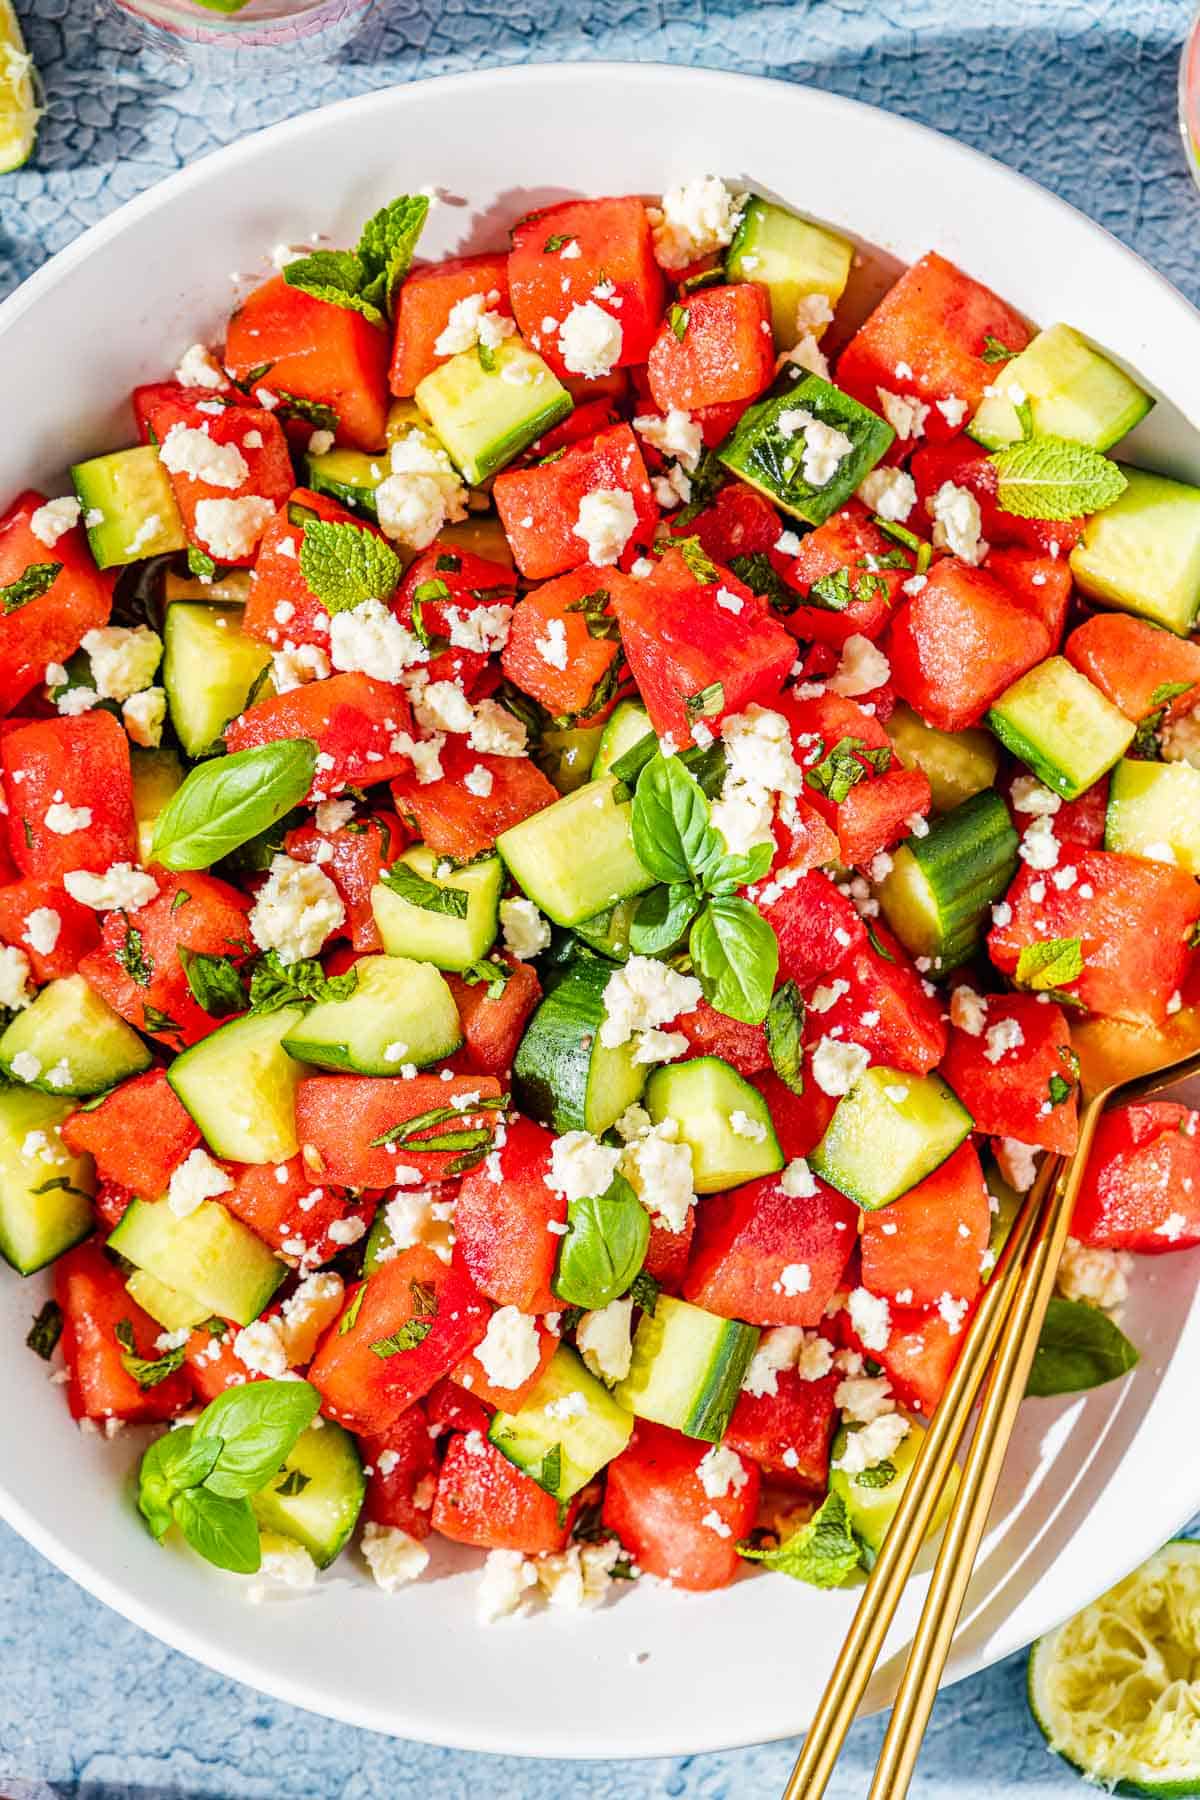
[988,657,1137,799]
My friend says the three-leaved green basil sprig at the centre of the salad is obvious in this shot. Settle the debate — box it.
[630,754,779,1024]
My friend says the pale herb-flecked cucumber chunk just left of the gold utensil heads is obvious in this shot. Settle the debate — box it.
[808,1067,973,1211]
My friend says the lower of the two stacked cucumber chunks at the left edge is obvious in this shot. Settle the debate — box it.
[0,1087,95,1274]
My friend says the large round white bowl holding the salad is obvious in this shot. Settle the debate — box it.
[0,65,1200,1757]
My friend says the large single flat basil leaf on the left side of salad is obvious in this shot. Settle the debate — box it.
[148,738,317,869]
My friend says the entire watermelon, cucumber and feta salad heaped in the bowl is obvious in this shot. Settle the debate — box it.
[0,176,1200,1618]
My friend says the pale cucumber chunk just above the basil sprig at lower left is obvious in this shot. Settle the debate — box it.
[108,1201,288,1325]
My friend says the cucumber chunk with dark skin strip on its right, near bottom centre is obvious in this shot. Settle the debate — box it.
[613,1294,759,1444]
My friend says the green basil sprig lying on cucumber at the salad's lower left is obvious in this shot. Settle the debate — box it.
[137,1381,320,1575]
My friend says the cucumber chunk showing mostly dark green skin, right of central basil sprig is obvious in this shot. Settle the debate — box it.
[876,788,1018,974]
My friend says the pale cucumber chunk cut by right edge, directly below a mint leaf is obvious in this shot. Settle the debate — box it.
[1070,464,1200,637]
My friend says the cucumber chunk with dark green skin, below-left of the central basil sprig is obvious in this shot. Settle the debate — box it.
[513,958,648,1138]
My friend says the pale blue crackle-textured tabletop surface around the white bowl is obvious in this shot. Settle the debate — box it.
[0,0,1200,1800]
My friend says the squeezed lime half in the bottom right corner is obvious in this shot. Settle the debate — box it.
[1029,1539,1200,1800]
